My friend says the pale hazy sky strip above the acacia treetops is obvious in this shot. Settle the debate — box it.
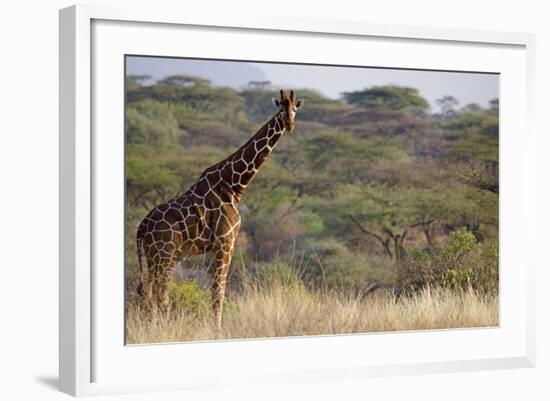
[126,56,499,110]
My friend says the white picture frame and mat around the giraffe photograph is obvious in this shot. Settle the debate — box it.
[59,5,536,396]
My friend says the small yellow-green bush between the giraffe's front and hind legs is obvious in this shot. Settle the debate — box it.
[170,280,211,316]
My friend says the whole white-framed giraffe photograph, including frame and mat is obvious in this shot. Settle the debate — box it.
[60,6,536,395]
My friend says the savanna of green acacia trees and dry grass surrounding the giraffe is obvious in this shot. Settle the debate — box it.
[126,76,499,343]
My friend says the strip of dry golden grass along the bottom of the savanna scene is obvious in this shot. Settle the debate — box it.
[126,284,499,344]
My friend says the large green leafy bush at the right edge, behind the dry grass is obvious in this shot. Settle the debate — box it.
[398,230,498,294]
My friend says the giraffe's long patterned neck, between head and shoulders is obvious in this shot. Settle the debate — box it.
[217,112,285,200]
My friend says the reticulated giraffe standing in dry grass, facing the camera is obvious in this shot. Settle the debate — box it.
[136,90,304,329]
